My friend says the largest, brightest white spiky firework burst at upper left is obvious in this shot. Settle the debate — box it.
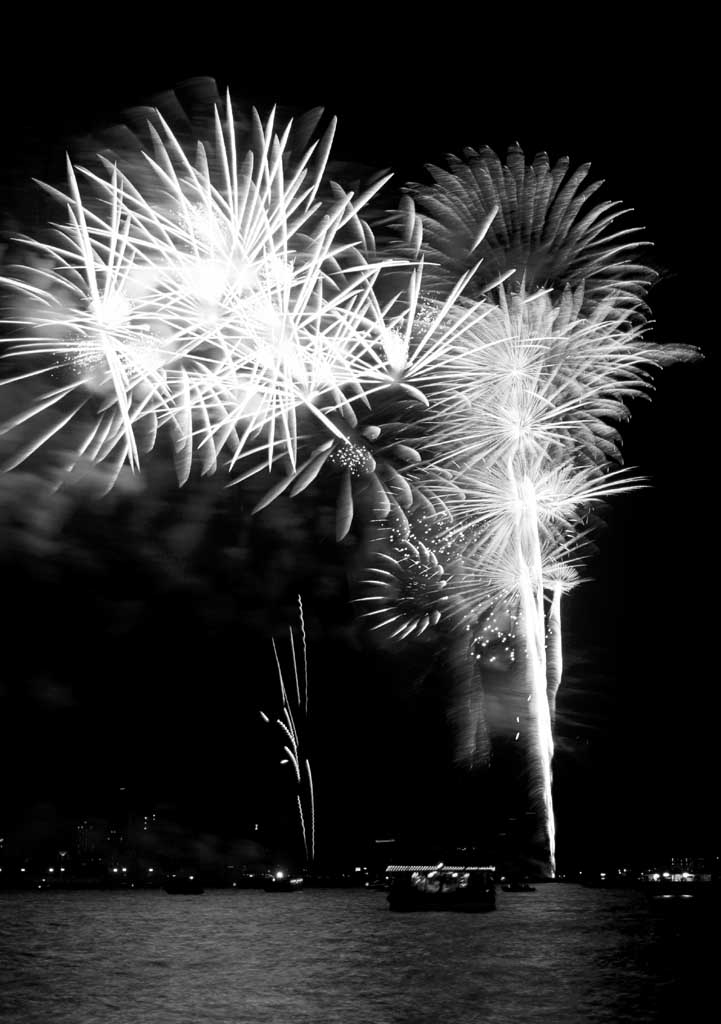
[2,100,417,489]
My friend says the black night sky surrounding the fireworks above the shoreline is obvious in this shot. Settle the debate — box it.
[0,12,719,860]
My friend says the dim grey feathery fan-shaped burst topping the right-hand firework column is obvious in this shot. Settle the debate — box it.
[393,145,654,309]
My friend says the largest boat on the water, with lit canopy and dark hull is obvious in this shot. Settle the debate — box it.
[386,863,496,913]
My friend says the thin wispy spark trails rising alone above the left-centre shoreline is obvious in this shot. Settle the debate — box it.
[260,595,315,866]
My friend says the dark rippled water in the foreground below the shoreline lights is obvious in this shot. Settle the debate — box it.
[0,885,718,1024]
